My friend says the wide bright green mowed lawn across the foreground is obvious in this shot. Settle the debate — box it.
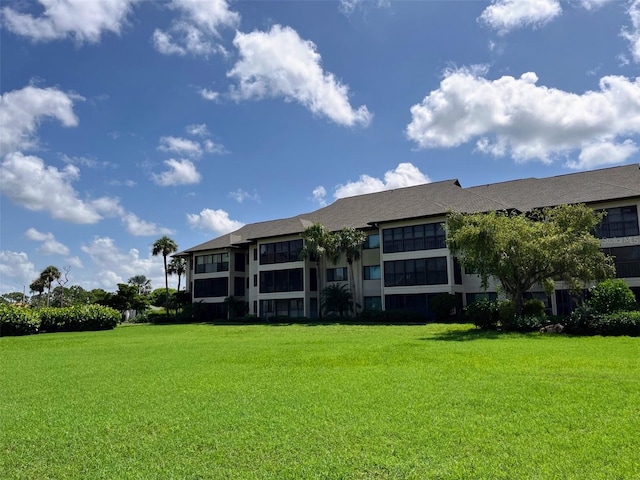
[0,325,640,480]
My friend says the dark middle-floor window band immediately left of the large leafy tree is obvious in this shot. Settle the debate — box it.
[384,257,449,287]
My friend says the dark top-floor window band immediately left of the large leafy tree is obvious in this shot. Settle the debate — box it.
[382,223,445,253]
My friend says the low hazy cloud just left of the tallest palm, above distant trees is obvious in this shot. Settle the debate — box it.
[81,237,164,290]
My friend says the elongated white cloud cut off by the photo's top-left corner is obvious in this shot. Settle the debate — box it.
[2,0,137,43]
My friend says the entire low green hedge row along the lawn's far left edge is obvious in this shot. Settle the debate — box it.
[0,305,121,336]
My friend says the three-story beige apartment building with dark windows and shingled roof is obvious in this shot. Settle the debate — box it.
[178,164,640,318]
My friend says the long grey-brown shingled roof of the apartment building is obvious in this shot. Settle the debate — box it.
[177,164,640,255]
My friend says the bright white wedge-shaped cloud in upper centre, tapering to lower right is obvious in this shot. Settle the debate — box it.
[227,25,372,126]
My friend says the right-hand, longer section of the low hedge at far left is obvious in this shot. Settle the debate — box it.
[38,305,121,333]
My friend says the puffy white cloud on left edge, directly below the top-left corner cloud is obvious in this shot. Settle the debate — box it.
[0,86,83,154]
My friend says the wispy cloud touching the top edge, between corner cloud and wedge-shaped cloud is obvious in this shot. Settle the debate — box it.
[153,0,240,57]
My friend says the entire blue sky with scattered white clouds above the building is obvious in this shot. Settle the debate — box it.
[0,0,640,292]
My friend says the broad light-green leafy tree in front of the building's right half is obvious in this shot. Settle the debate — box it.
[446,205,615,315]
